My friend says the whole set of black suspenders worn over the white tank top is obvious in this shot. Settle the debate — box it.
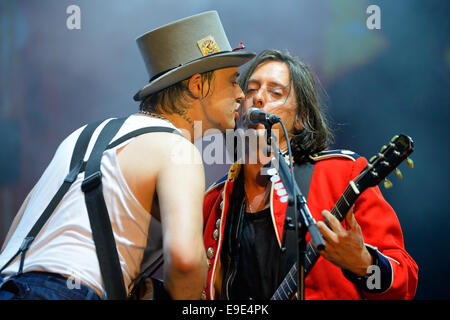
[0,118,179,299]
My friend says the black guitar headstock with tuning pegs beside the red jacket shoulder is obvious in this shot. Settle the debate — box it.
[355,134,414,191]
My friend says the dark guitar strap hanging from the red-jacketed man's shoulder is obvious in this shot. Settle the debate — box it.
[279,162,315,282]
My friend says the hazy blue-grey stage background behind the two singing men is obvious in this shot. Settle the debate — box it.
[0,0,450,299]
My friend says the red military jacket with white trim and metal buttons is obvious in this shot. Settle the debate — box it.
[203,151,418,300]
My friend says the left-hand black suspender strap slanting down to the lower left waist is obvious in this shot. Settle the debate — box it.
[0,121,102,274]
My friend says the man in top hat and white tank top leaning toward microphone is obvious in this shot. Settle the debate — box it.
[0,11,254,299]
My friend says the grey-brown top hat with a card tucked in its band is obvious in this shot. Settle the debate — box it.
[134,11,255,101]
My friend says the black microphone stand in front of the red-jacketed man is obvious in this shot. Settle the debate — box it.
[266,120,325,300]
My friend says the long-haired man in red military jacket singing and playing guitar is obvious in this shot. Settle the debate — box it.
[203,50,418,299]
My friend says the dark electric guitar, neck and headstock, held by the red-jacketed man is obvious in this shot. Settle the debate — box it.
[271,134,414,300]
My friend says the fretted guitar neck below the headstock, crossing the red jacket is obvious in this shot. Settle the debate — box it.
[271,181,360,300]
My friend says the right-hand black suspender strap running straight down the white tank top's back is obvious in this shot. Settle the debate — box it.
[81,118,127,299]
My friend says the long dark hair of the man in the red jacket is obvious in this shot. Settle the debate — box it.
[239,49,334,164]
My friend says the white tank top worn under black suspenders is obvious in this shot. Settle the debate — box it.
[0,115,179,297]
